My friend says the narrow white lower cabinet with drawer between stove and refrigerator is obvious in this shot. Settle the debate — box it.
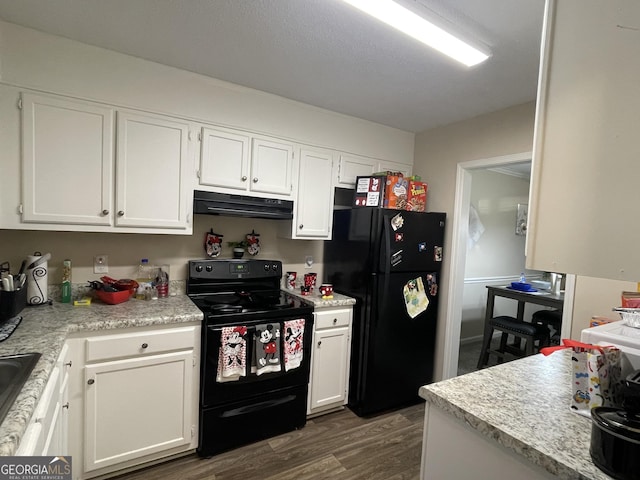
[307,307,353,415]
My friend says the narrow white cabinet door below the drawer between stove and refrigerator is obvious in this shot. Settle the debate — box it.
[309,327,349,411]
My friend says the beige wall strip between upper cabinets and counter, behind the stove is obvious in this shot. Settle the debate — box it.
[0,215,323,290]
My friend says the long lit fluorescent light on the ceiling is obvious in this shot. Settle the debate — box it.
[343,0,489,67]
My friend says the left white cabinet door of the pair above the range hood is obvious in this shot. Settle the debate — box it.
[200,128,249,191]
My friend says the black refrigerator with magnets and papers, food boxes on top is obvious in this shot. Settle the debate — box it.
[324,207,446,416]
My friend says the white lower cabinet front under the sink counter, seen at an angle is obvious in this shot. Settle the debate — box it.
[16,345,70,456]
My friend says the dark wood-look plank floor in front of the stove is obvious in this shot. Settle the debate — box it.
[117,403,424,480]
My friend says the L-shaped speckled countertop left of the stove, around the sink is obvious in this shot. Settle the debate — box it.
[0,295,203,455]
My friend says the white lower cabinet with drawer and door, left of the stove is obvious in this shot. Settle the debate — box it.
[70,325,200,479]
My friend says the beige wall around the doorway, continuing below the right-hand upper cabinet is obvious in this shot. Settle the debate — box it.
[414,102,637,379]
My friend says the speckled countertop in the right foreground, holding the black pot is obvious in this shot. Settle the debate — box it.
[420,351,611,480]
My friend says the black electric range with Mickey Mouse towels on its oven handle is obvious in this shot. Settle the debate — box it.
[187,259,313,457]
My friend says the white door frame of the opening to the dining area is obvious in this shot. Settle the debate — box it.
[442,151,575,380]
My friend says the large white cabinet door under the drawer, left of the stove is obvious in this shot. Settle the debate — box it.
[84,351,194,472]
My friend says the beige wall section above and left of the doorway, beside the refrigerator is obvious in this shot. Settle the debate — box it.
[413,102,535,379]
